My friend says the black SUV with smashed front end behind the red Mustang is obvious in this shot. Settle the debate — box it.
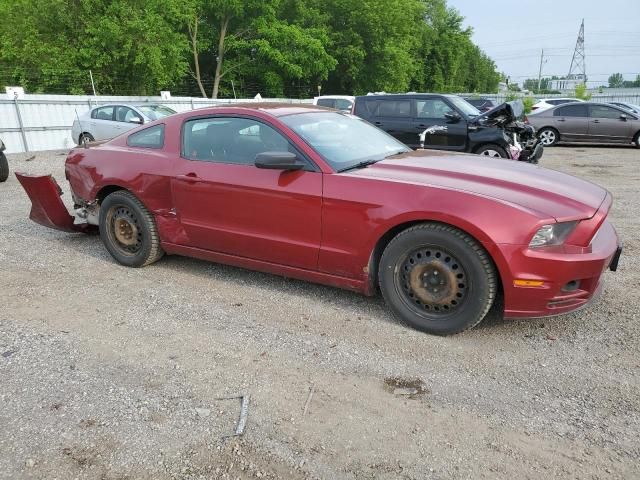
[354,93,542,163]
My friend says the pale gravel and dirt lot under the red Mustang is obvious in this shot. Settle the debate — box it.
[0,147,640,480]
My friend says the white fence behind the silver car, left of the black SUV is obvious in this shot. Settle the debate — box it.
[0,94,312,153]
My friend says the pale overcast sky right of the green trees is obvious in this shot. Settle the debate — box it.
[448,0,640,87]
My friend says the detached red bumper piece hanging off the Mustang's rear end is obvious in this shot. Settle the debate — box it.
[16,172,96,233]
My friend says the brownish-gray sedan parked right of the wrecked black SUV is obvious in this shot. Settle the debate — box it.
[528,102,640,148]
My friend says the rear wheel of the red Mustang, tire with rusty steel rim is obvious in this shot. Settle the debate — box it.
[99,190,164,267]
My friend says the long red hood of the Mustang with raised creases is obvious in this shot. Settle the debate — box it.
[349,150,607,222]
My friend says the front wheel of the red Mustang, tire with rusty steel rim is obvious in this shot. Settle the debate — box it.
[378,223,498,335]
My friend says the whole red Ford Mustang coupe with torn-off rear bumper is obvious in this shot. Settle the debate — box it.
[18,103,621,334]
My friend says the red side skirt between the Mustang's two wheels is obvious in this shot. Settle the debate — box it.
[162,242,367,294]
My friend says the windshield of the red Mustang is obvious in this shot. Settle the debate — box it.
[281,112,409,171]
